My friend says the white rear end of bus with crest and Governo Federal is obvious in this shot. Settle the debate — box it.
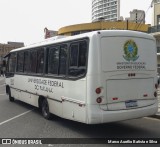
[87,31,158,123]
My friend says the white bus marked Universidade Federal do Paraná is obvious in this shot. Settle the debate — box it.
[6,30,158,124]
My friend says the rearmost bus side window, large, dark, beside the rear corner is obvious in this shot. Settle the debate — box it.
[69,41,87,77]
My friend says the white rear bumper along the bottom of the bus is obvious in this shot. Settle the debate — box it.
[87,103,158,124]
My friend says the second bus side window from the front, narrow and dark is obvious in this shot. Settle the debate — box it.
[17,52,24,72]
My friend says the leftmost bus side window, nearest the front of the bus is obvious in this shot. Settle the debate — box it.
[8,53,17,73]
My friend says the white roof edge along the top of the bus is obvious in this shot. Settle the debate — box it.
[10,30,155,52]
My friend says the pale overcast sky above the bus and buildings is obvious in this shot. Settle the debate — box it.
[0,0,153,45]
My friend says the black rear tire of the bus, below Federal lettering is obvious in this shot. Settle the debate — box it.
[41,98,51,120]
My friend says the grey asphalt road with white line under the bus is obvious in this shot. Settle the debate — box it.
[0,78,160,147]
